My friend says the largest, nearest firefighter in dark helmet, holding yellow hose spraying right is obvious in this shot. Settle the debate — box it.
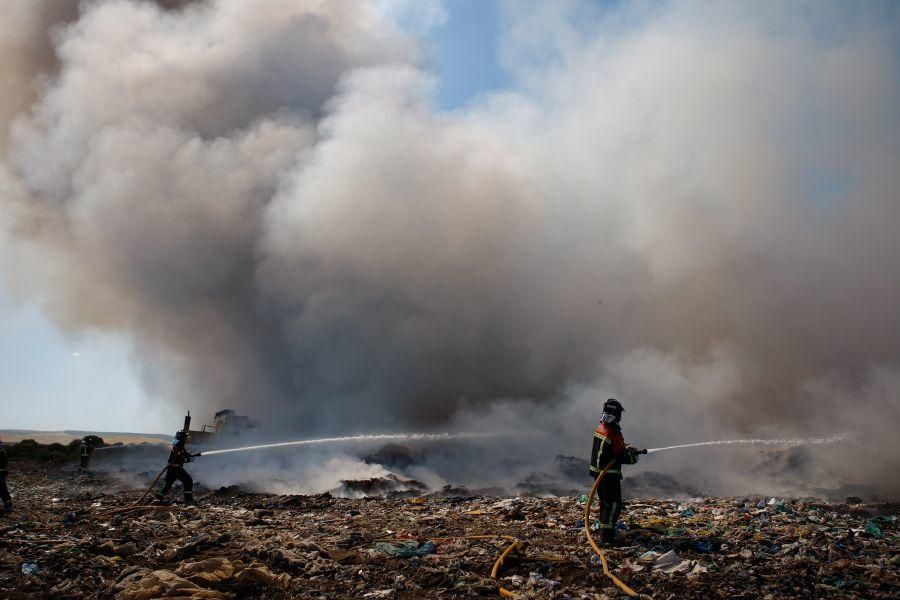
[591,398,638,545]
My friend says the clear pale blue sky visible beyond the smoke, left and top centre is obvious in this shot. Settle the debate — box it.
[0,0,508,433]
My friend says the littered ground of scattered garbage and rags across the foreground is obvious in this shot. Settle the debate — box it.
[0,463,900,600]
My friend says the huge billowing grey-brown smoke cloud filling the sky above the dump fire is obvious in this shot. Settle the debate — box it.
[0,0,900,488]
